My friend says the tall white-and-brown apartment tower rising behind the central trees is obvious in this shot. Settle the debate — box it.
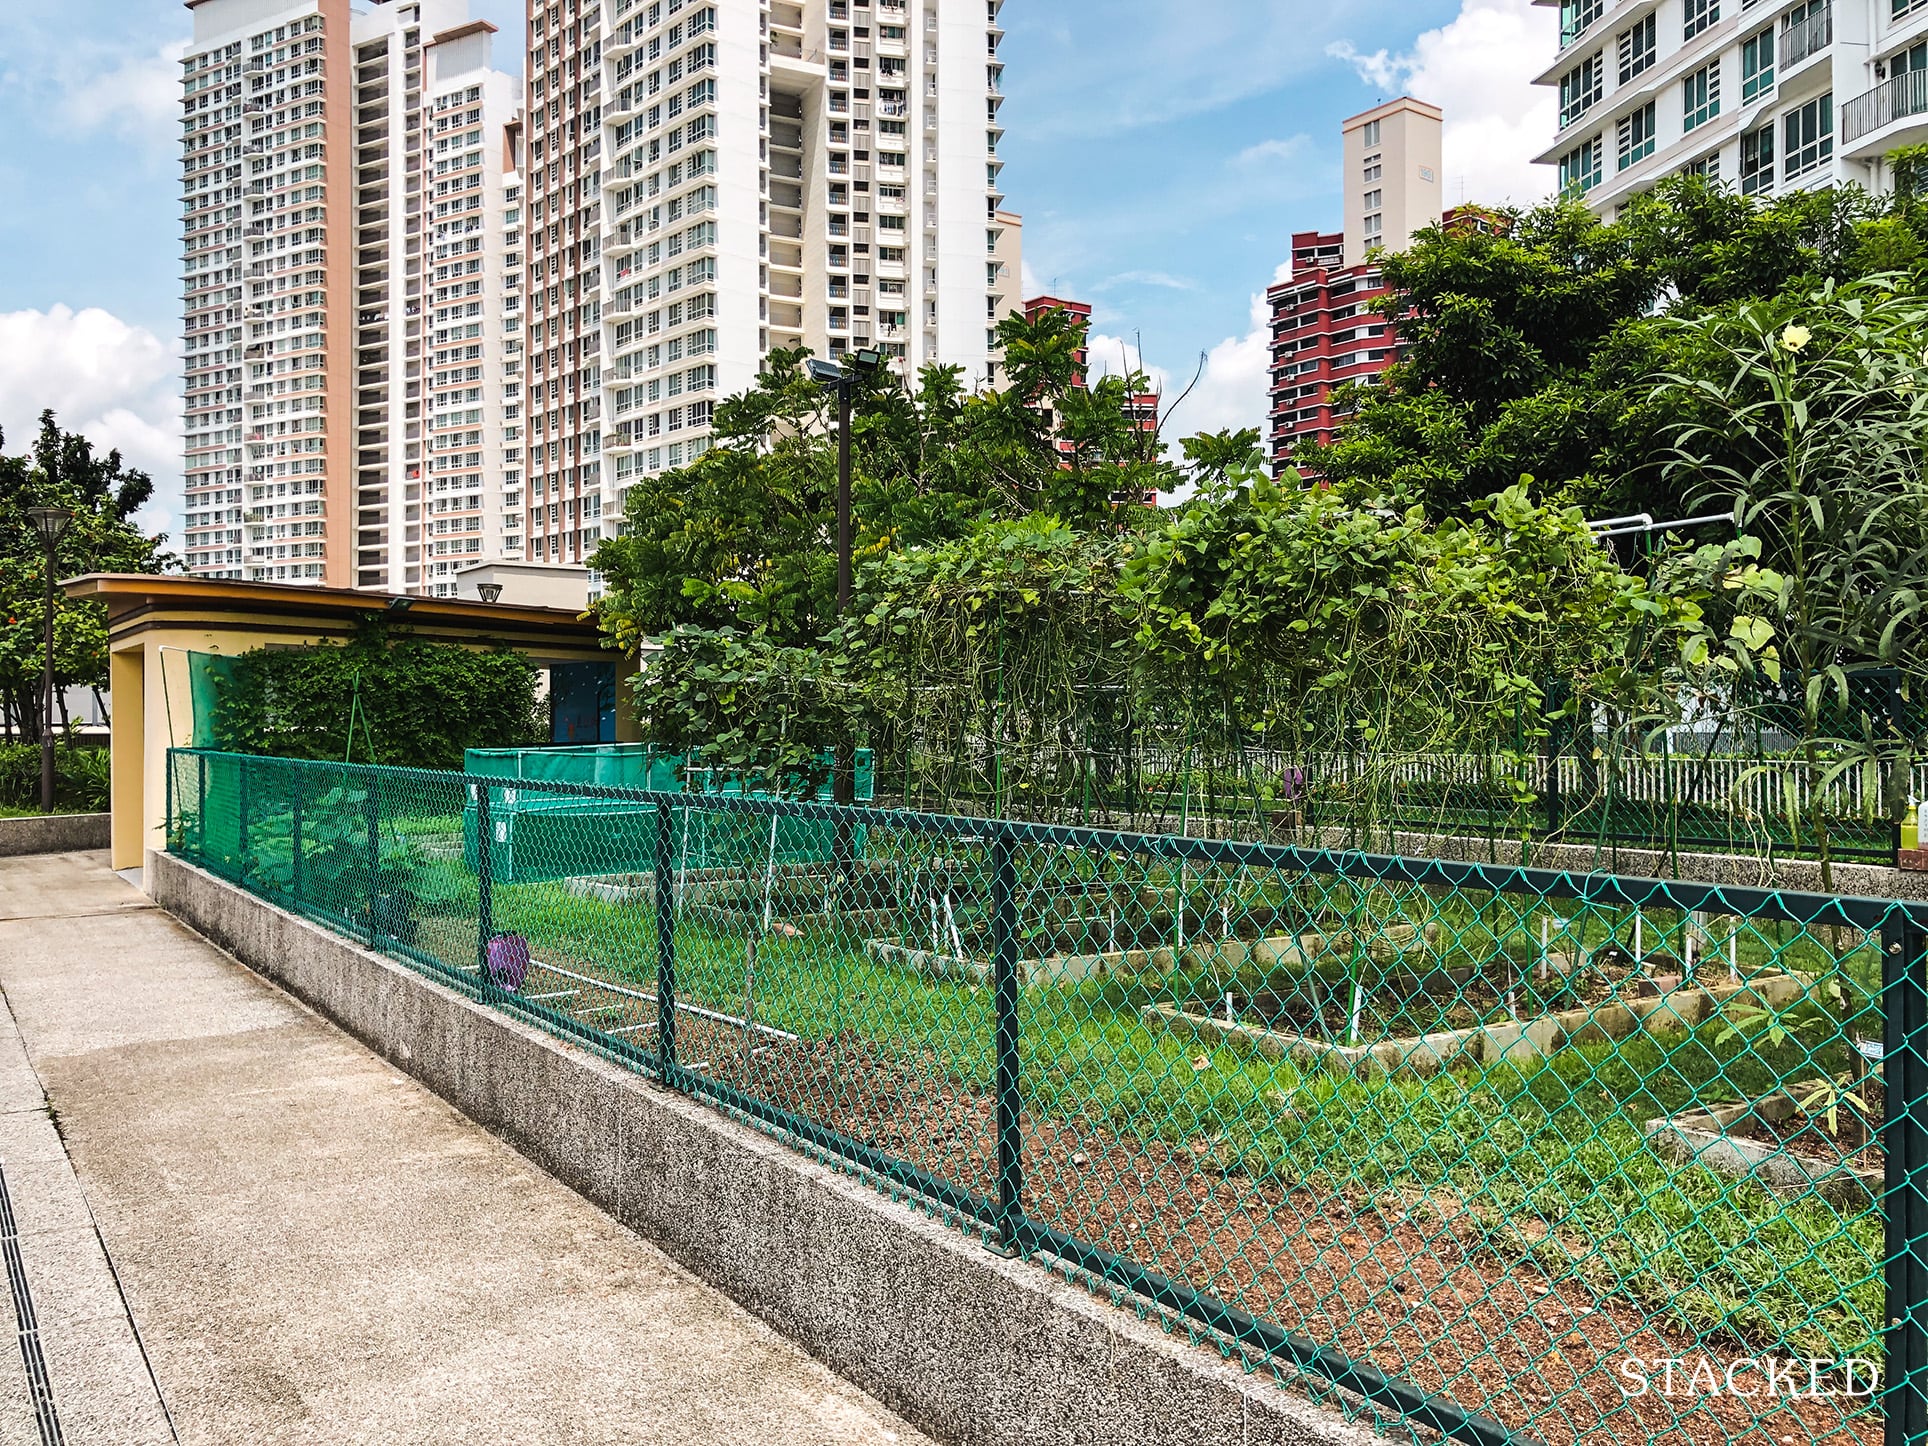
[526,0,1016,578]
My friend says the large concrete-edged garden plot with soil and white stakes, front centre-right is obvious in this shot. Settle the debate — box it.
[1143,920,1812,1076]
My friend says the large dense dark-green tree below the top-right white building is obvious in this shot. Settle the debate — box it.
[1296,177,1928,517]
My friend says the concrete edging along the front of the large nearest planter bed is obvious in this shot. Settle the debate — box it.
[1143,974,1810,1078]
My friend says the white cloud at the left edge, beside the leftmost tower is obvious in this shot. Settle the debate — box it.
[0,307,181,540]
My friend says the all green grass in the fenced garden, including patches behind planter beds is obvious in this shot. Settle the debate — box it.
[191,817,1882,1355]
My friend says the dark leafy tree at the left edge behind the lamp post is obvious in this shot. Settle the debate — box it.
[0,411,177,742]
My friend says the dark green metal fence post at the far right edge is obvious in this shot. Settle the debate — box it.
[1882,910,1928,1446]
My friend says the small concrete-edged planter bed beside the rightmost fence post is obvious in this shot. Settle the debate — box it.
[1645,1080,1886,1209]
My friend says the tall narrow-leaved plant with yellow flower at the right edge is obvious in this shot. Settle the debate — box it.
[1654,276,1928,879]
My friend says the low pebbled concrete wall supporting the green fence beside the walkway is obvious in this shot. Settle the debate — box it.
[147,854,1384,1446]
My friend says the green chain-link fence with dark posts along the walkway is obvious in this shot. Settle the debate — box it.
[168,750,1928,1446]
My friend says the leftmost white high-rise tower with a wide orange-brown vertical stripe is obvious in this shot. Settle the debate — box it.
[181,0,521,592]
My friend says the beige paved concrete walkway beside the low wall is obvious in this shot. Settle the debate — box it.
[0,854,925,1446]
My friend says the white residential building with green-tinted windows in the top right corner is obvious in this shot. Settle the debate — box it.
[1537,0,1928,216]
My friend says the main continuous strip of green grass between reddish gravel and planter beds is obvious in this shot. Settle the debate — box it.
[485,889,1882,1355]
